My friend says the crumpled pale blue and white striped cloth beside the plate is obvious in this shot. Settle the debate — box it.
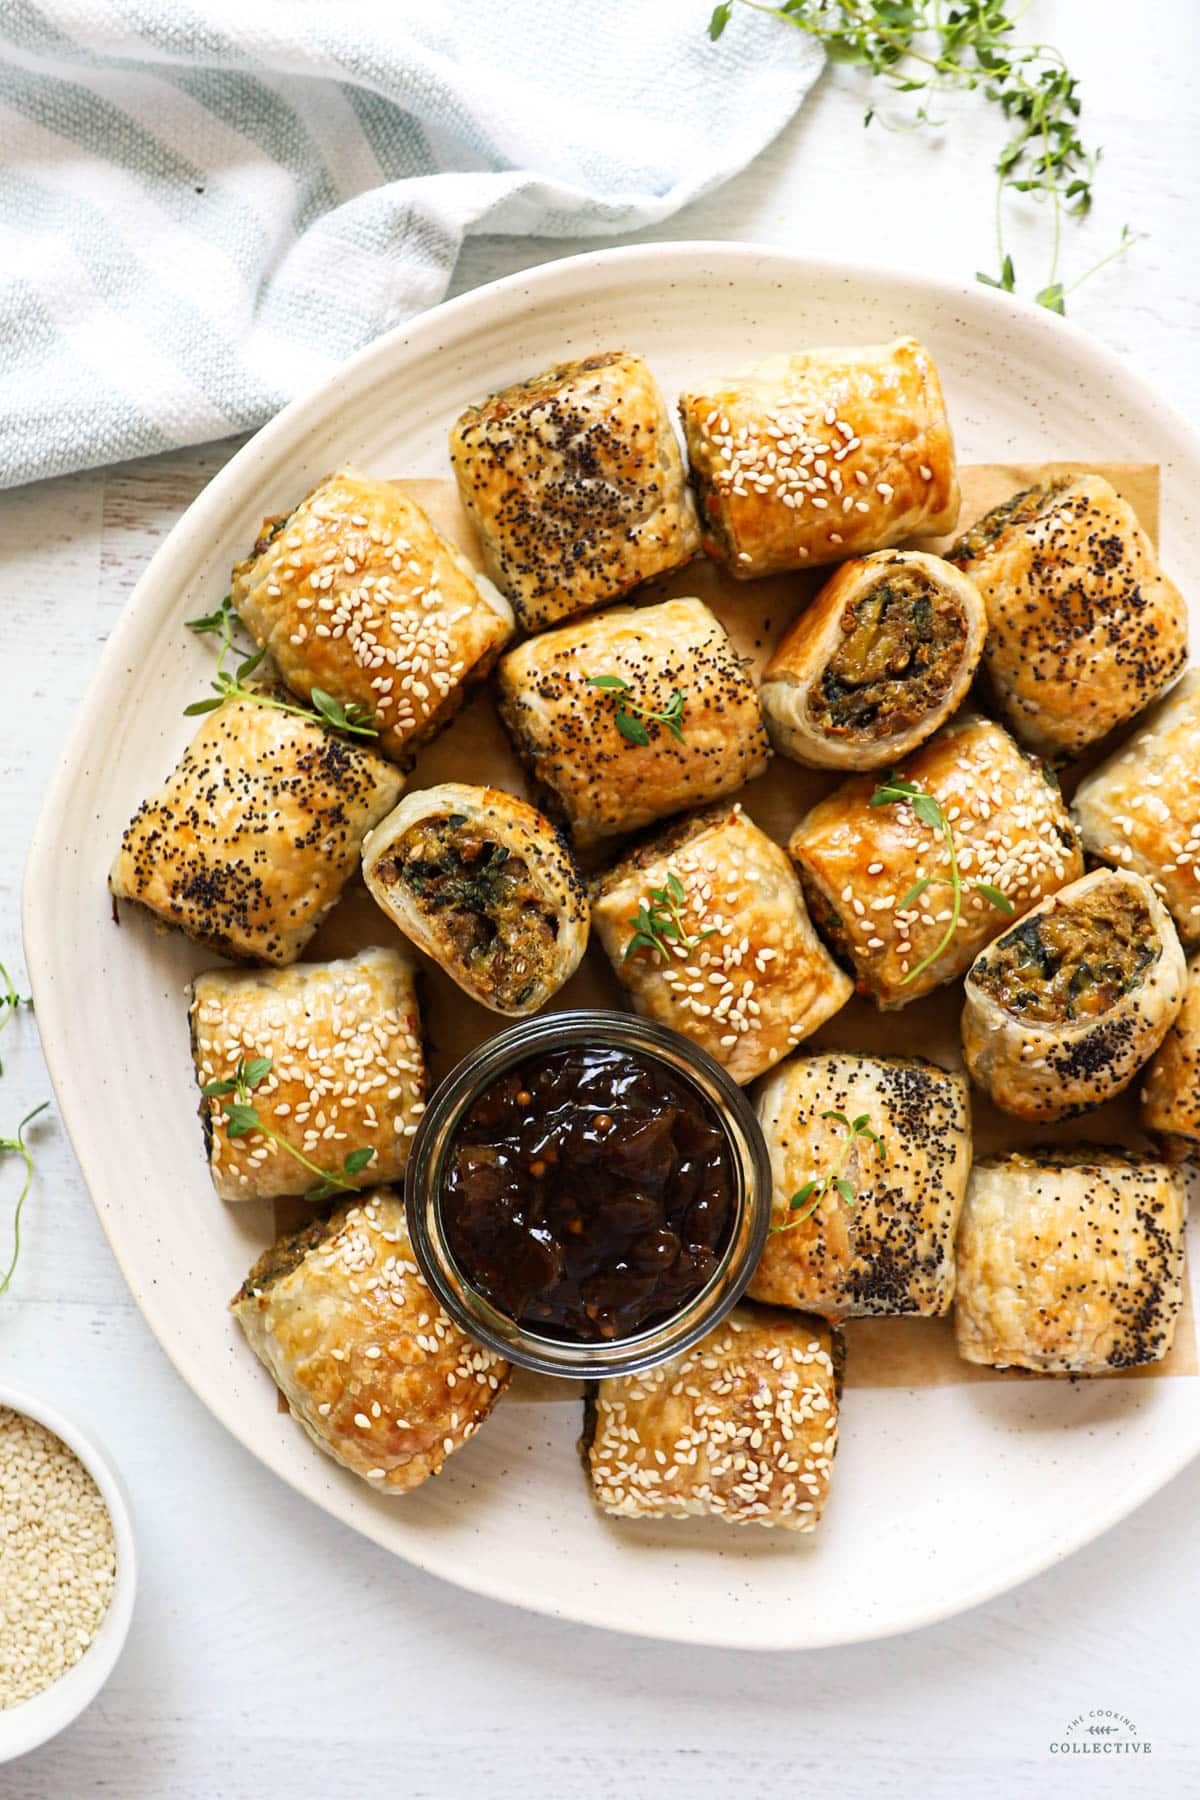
[0,0,820,486]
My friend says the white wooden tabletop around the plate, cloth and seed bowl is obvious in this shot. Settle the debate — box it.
[0,0,1200,1800]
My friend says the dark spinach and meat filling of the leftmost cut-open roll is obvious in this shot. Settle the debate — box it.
[380,812,558,1006]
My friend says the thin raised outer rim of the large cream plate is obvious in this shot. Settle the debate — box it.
[22,239,1200,1651]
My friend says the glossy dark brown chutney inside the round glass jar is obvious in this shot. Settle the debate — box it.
[443,1046,734,1343]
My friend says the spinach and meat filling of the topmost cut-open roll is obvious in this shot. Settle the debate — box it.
[810,569,966,738]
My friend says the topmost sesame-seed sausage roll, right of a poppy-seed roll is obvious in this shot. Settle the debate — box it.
[680,338,959,580]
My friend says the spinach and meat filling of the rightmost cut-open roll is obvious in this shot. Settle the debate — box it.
[973,882,1160,1024]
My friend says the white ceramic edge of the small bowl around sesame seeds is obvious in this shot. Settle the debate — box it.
[0,1382,137,1762]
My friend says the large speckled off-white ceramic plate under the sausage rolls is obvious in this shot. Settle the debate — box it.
[25,243,1200,1649]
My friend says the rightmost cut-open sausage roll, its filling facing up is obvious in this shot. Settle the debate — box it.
[963,869,1187,1121]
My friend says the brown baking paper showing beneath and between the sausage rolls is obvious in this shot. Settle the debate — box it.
[277,463,1196,1400]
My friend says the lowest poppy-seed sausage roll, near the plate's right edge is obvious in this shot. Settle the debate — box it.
[954,1143,1187,1375]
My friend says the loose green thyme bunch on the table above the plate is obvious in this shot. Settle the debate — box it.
[709,0,1137,313]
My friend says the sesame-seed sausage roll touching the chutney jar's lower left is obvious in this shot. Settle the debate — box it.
[232,1188,511,1494]
